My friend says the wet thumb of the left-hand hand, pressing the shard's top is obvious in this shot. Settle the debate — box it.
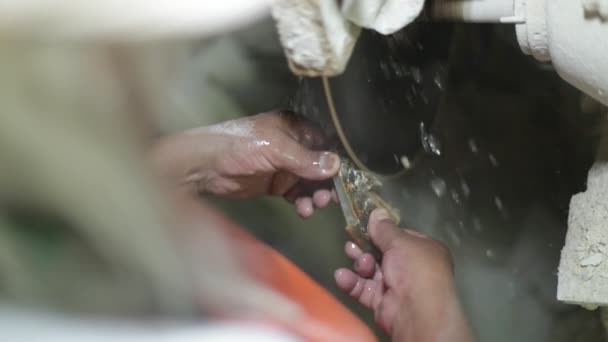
[270,139,340,180]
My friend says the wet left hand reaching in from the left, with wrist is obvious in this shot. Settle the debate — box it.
[154,111,340,217]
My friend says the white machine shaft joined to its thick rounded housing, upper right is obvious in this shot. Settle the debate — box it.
[430,0,608,105]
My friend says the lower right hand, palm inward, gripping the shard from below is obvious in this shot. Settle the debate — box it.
[335,209,473,341]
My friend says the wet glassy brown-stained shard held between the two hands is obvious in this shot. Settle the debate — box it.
[334,158,399,261]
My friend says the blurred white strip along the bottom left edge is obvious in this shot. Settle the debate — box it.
[0,304,298,342]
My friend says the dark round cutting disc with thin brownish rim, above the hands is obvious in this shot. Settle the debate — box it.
[294,23,451,175]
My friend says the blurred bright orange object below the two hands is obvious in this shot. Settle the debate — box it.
[210,206,377,342]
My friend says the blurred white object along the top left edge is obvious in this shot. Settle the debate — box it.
[0,0,270,40]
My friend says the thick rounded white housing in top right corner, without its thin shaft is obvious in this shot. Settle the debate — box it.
[516,0,608,105]
